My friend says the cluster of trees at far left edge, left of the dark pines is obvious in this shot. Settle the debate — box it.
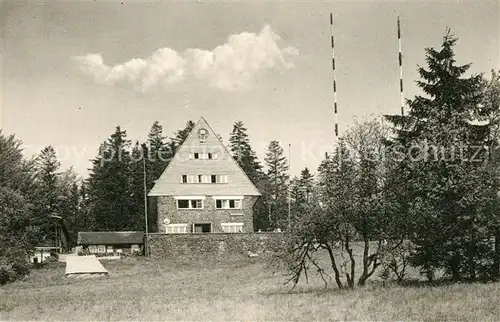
[0,140,80,284]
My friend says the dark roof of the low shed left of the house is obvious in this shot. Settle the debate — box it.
[78,231,144,245]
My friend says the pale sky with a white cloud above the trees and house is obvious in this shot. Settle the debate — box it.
[0,0,500,176]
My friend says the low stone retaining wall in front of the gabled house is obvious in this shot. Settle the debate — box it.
[148,232,284,259]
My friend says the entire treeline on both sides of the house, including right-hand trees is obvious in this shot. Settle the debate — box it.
[0,30,500,288]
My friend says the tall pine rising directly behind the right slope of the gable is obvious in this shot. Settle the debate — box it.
[229,121,262,184]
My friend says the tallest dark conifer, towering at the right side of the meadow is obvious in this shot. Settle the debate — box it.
[388,31,492,280]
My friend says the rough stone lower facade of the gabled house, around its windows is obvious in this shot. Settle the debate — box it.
[157,196,258,233]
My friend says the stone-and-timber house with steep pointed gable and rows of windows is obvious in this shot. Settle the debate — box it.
[148,118,260,234]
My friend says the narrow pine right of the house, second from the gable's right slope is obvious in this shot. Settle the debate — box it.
[264,141,289,228]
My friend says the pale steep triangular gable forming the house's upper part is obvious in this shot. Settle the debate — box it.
[148,117,260,196]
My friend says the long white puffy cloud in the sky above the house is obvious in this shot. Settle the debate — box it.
[74,25,299,92]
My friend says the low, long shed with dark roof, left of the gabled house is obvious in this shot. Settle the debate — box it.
[78,231,144,255]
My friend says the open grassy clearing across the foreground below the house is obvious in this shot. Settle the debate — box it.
[0,253,500,321]
